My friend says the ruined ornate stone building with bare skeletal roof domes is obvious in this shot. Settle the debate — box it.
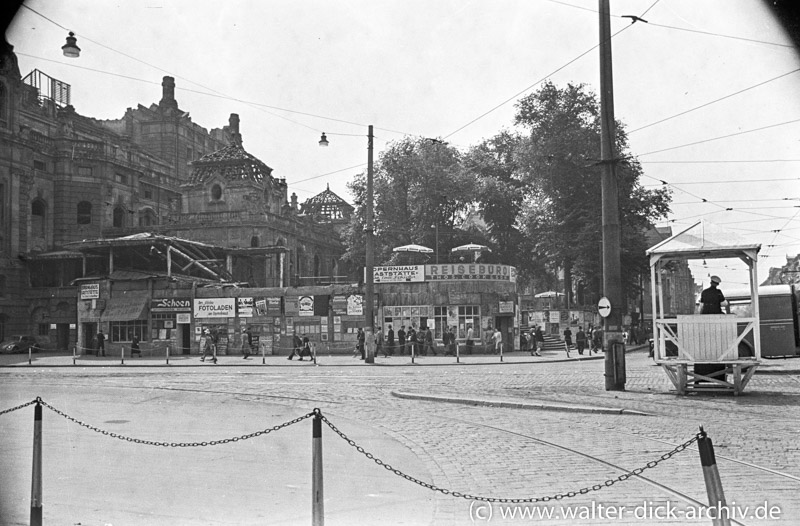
[0,46,350,349]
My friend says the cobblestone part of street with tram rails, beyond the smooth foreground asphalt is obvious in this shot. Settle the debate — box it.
[0,352,800,525]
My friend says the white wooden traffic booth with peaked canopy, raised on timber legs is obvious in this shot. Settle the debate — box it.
[647,221,761,395]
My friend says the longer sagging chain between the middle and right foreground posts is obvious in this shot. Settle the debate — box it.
[322,410,702,504]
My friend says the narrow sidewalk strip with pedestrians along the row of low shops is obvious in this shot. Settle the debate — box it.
[0,346,620,367]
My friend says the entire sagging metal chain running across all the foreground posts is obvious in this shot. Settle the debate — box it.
[0,397,705,504]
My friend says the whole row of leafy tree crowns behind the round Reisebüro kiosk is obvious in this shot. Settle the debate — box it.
[345,82,670,310]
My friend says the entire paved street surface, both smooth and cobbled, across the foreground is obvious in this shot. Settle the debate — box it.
[0,352,800,526]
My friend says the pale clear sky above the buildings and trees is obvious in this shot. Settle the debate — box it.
[6,0,800,287]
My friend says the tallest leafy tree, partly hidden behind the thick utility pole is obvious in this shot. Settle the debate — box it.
[515,82,670,308]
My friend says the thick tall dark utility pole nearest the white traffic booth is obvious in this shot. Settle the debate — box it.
[599,0,625,391]
